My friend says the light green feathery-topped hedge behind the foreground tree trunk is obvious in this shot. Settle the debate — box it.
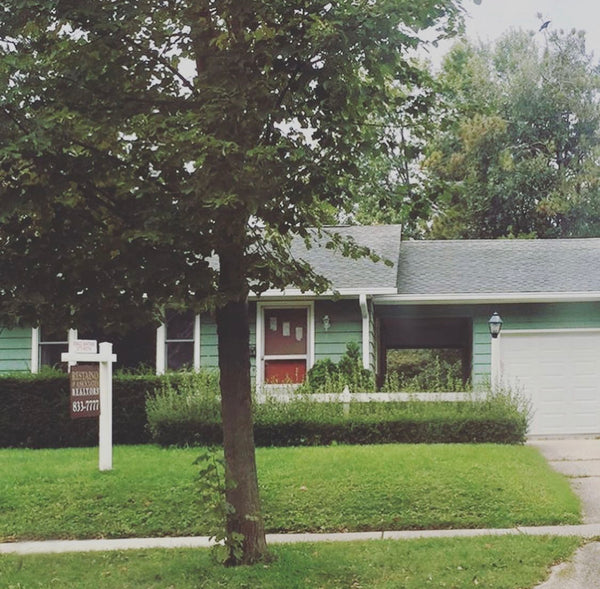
[147,374,529,446]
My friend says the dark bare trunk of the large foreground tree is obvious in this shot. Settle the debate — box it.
[217,245,268,565]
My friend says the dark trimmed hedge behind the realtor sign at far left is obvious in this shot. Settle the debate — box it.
[0,372,183,448]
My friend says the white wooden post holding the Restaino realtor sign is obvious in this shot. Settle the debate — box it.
[61,340,117,470]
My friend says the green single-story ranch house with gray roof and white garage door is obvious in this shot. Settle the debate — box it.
[0,225,600,435]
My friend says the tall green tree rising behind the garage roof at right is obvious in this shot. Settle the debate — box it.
[426,25,600,238]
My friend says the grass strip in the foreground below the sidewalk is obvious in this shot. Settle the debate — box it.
[0,536,578,589]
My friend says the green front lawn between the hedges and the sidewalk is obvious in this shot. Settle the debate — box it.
[0,444,580,541]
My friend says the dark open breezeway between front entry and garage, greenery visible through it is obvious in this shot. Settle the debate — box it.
[379,317,472,392]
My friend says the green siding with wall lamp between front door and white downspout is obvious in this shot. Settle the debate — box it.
[315,299,362,362]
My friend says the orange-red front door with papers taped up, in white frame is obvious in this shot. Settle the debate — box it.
[259,307,312,385]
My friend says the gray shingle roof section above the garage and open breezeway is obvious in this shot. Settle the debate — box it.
[398,239,600,295]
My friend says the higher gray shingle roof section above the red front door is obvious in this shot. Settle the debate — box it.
[292,225,401,292]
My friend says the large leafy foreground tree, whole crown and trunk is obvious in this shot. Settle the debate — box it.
[0,0,460,564]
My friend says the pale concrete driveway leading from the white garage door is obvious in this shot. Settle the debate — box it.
[528,438,600,589]
